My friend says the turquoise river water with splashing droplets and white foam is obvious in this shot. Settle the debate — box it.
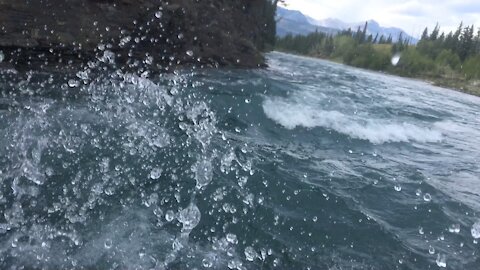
[0,53,480,270]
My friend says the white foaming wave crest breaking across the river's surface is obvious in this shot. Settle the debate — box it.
[263,99,443,144]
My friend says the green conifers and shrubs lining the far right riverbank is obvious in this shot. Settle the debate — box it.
[276,23,480,80]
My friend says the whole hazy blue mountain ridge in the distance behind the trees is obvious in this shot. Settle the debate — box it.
[277,7,418,43]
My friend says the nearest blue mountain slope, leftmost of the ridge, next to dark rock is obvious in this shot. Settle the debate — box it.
[276,7,338,37]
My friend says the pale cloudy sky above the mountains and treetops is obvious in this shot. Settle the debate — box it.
[287,0,480,36]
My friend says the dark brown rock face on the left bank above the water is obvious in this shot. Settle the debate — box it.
[0,0,270,70]
